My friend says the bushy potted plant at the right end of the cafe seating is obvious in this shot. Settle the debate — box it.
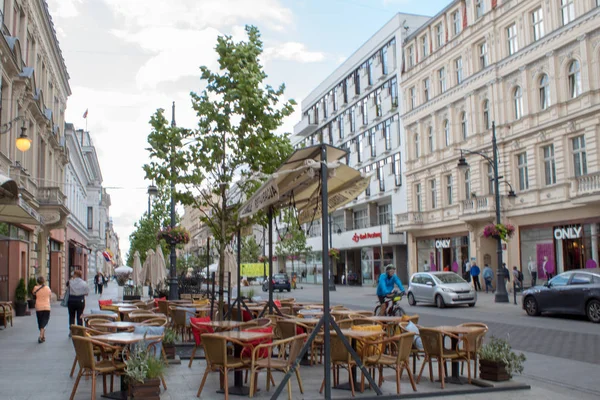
[478,336,525,382]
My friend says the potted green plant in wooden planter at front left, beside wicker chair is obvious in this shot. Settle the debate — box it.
[125,341,165,400]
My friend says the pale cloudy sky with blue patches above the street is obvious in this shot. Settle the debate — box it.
[47,0,450,258]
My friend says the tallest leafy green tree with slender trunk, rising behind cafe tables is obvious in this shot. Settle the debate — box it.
[144,26,295,315]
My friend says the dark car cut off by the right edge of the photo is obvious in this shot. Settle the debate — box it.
[523,268,600,323]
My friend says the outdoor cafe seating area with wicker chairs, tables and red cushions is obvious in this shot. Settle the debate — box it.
[70,296,488,399]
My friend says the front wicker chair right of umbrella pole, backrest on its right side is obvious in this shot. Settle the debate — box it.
[360,332,417,394]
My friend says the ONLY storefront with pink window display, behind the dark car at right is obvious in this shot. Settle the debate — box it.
[519,219,600,280]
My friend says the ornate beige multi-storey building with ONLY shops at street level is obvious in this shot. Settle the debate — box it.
[396,0,600,284]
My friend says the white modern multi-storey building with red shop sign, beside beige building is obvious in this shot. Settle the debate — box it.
[292,13,429,285]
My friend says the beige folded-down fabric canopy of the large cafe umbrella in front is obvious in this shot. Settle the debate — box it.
[240,145,371,223]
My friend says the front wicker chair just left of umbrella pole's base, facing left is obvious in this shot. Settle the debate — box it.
[250,334,307,400]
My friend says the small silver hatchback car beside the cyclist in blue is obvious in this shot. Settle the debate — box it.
[407,272,477,308]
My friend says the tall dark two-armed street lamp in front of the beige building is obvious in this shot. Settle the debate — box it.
[457,122,517,303]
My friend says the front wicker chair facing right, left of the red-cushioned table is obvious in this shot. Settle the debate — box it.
[197,333,250,400]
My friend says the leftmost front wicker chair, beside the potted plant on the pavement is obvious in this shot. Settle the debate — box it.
[70,336,125,400]
